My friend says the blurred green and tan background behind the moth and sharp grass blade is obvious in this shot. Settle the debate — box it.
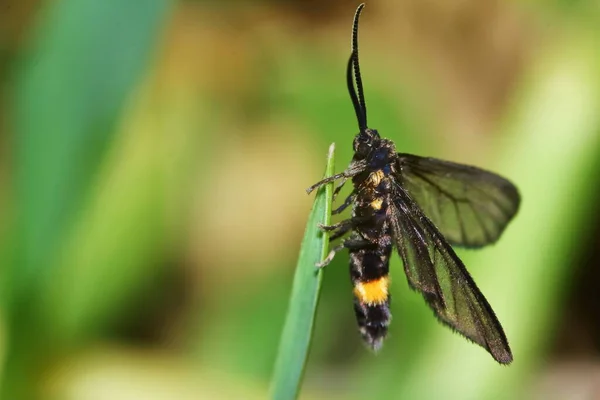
[0,0,600,400]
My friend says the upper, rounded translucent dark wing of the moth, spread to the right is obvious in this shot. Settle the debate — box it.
[396,153,520,247]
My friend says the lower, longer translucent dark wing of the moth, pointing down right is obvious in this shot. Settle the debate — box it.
[390,187,512,364]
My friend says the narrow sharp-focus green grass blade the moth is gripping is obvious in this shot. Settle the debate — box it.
[271,144,335,400]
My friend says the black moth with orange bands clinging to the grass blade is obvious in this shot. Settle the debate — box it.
[307,4,520,364]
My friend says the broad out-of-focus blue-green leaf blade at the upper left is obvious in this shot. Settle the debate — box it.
[10,0,169,302]
